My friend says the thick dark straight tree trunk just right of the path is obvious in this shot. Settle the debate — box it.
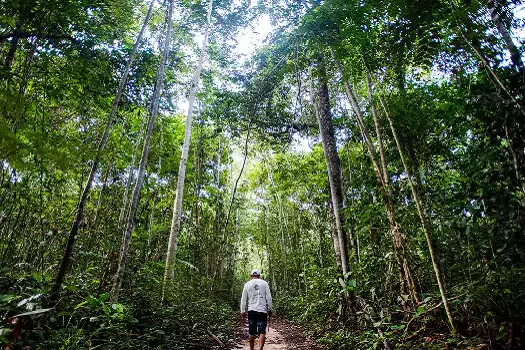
[317,55,349,275]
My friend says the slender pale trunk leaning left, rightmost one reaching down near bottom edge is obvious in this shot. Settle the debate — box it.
[379,86,456,334]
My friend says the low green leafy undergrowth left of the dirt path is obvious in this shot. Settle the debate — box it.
[0,267,234,350]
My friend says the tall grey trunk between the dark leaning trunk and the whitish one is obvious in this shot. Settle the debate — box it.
[111,0,174,301]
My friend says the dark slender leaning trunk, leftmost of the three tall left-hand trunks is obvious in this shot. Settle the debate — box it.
[49,0,155,304]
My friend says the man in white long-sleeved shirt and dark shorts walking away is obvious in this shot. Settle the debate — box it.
[241,270,272,350]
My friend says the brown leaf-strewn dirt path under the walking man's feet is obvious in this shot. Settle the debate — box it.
[233,317,323,350]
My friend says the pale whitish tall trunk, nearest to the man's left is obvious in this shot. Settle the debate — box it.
[162,0,213,299]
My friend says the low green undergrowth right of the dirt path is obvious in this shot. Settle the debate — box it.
[275,268,525,350]
